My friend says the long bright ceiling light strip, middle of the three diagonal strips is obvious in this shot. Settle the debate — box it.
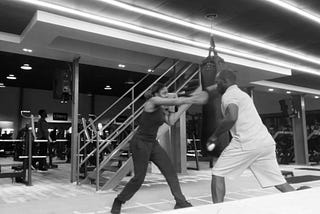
[98,0,320,65]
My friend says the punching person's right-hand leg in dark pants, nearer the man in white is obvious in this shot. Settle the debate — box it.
[150,142,191,208]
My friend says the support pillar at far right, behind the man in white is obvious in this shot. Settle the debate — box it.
[292,95,309,165]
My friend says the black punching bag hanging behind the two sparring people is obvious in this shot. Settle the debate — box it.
[201,37,229,157]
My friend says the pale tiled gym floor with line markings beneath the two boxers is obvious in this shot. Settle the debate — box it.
[0,157,320,214]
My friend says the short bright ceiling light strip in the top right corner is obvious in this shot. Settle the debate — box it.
[265,0,320,24]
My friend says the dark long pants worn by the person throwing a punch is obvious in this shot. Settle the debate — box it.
[117,136,186,203]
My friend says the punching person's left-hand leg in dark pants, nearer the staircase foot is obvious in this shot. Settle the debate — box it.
[111,140,152,214]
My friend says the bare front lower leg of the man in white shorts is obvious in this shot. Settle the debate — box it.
[211,175,226,203]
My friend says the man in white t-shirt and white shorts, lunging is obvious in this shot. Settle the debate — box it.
[207,70,302,203]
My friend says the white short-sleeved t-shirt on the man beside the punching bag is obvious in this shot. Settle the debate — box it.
[221,85,275,149]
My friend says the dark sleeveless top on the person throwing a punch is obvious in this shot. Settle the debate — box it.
[137,107,165,140]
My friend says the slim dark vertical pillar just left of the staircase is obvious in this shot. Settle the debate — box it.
[70,58,80,182]
